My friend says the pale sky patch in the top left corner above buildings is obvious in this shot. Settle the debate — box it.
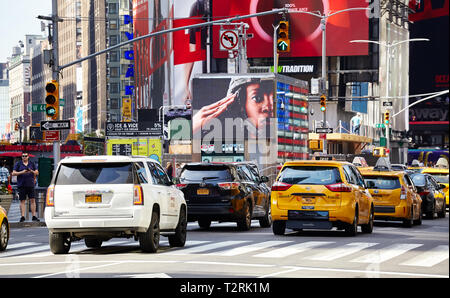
[0,0,52,63]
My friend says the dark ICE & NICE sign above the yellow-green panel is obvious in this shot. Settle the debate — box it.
[106,121,162,137]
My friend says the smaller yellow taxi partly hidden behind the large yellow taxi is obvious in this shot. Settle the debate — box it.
[361,167,422,227]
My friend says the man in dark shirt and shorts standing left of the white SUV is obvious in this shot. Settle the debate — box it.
[12,152,39,222]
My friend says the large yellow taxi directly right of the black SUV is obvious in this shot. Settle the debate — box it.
[271,160,374,236]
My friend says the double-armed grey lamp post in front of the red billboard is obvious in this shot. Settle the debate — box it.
[289,7,370,154]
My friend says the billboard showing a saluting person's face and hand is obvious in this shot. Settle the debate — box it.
[192,75,275,142]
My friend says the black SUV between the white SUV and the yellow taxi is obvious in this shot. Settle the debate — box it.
[177,163,272,230]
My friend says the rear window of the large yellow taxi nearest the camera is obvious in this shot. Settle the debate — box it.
[278,166,342,185]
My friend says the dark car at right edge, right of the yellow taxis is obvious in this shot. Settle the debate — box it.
[411,173,445,219]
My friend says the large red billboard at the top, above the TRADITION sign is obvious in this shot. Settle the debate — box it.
[213,0,369,58]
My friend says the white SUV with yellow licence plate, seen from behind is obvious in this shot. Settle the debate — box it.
[45,156,187,254]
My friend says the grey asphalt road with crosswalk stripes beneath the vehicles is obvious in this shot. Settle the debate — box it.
[0,213,449,280]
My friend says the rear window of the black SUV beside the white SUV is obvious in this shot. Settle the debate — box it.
[180,165,233,182]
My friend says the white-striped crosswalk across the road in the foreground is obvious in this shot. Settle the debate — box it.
[0,239,449,268]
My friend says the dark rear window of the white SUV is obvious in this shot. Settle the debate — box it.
[55,162,133,185]
